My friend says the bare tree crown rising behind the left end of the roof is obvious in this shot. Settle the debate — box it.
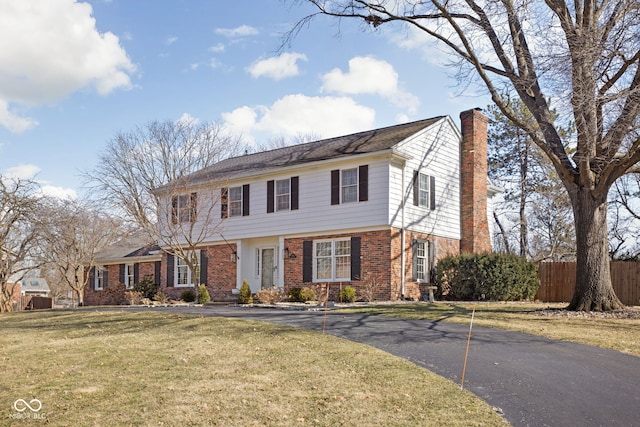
[83,118,241,232]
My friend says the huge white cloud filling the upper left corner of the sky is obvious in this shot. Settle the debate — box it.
[0,0,136,130]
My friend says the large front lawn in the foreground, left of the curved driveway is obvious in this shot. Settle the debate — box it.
[0,310,507,426]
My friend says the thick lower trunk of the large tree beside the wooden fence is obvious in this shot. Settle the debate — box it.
[568,188,624,311]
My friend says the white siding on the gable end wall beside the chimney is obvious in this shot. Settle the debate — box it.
[389,117,461,239]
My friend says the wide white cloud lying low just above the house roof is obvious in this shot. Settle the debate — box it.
[222,94,375,137]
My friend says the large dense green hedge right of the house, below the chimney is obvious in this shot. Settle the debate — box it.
[437,254,540,301]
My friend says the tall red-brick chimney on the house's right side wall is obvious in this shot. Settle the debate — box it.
[460,109,491,253]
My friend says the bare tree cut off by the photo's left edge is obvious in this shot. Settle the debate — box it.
[0,175,40,312]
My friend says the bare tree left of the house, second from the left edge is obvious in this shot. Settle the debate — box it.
[40,199,126,305]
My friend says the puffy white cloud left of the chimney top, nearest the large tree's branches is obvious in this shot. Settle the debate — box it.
[321,56,420,112]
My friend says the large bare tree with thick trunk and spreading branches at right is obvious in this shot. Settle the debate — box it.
[292,0,640,311]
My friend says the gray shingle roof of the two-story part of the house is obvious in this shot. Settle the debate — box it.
[165,116,444,190]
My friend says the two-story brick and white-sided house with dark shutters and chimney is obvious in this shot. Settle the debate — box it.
[85,110,494,301]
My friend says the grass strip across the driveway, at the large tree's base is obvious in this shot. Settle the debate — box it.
[342,302,640,356]
